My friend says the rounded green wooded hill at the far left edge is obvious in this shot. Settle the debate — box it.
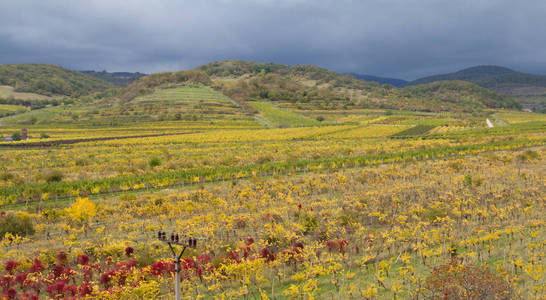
[0,64,115,97]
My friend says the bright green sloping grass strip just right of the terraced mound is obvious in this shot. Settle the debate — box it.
[249,102,320,127]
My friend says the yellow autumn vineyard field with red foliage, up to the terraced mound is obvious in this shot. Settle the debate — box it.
[0,102,546,299]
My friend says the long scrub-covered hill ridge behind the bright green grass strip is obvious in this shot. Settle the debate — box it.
[197,61,519,112]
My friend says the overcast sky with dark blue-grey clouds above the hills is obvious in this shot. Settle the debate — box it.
[0,0,546,80]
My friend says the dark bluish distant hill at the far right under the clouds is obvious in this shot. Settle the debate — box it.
[408,66,546,110]
